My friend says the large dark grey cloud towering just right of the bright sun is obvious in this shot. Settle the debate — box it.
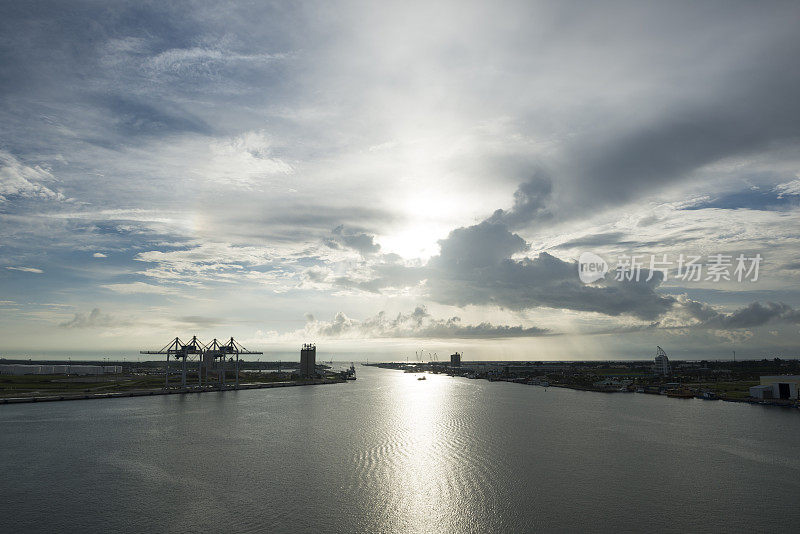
[334,219,800,331]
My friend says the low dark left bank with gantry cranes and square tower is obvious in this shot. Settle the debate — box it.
[0,336,356,404]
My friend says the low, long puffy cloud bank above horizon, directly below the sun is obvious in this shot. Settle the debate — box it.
[303,306,550,339]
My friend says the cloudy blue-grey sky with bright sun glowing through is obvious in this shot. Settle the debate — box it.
[0,1,800,360]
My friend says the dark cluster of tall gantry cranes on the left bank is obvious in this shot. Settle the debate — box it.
[139,336,264,389]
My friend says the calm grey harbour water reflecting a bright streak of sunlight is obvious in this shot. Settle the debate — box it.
[0,367,800,533]
